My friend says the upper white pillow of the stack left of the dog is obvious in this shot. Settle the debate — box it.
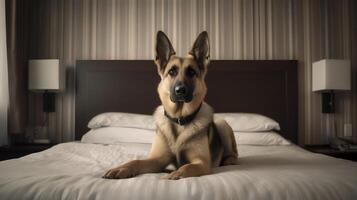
[88,112,156,130]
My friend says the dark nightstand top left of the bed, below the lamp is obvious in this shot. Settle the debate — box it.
[0,144,55,161]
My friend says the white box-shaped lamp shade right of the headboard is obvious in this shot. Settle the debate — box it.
[312,59,351,91]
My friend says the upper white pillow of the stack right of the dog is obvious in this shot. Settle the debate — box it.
[214,113,280,132]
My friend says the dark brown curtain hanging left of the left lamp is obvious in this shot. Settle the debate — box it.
[6,0,29,143]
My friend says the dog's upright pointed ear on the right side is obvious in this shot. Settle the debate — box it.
[189,31,210,70]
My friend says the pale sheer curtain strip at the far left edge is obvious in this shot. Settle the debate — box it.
[0,0,9,146]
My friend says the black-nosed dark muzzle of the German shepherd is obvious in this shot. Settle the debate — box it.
[170,82,193,103]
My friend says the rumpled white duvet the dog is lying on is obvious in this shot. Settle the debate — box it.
[0,142,357,200]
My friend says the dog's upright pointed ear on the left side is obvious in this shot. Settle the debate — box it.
[155,31,176,71]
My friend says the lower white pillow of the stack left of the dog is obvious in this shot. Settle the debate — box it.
[81,127,155,144]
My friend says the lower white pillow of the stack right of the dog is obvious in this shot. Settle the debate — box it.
[234,131,291,145]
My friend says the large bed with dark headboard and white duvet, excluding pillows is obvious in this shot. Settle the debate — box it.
[0,60,357,199]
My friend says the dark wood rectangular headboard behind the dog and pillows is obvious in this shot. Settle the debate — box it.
[75,60,298,143]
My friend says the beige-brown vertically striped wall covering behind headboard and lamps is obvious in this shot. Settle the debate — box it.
[23,0,357,144]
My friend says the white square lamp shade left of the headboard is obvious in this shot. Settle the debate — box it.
[28,59,60,90]
